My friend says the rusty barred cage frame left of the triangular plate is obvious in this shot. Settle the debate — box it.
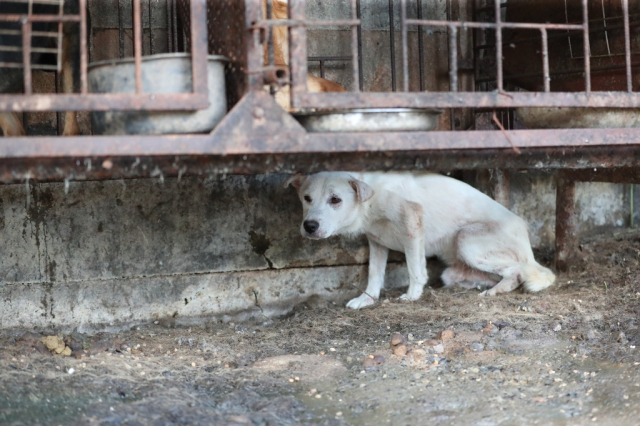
[0,0,209,112]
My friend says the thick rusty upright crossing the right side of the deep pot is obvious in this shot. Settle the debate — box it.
[191,0,209,97]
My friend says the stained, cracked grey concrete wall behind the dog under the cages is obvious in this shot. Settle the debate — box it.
[0,173,625,330]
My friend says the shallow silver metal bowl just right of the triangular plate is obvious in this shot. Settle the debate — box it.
[293,108,443,133]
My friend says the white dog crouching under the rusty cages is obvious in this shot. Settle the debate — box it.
[285,172,555,309]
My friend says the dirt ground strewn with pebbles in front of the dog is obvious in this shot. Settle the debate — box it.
[0,229,640,426]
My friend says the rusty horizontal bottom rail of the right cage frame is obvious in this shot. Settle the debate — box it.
[298,92,640,109]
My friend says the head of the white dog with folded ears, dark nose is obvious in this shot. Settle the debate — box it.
[285,172,373,239]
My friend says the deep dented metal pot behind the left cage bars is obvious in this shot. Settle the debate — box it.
[88,53,228,135]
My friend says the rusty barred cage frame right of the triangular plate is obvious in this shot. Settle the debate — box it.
[276,0,640,110]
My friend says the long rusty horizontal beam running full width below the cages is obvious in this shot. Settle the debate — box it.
[5,129,640,159]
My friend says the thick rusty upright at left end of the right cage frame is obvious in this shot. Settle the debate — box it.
[289,0,308,108]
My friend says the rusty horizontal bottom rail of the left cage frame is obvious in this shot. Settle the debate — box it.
[0,93,209,111]
